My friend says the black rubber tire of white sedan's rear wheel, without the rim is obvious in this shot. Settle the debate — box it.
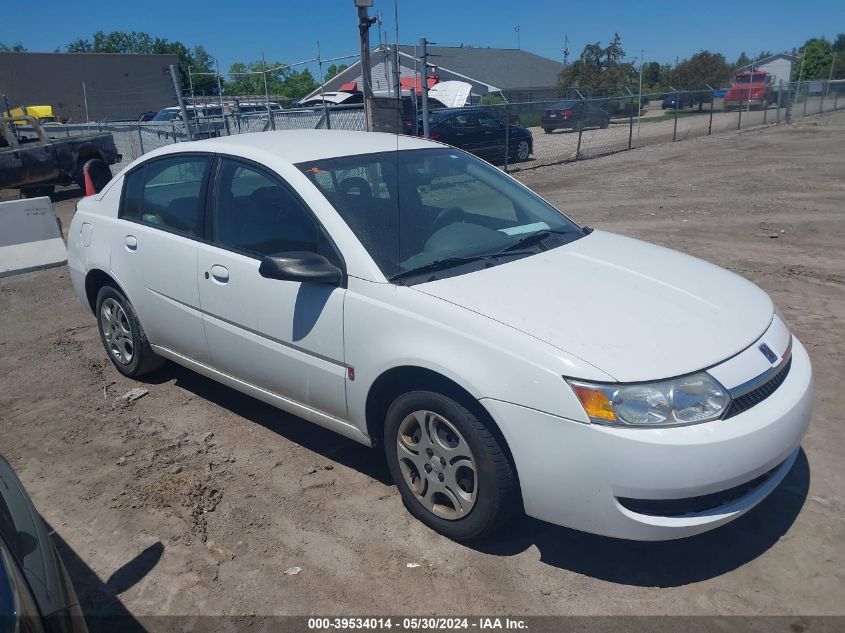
[95,284,165,378]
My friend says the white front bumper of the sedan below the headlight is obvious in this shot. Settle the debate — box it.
[481,338,813,541]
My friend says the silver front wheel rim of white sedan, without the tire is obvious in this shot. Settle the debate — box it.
[396,410,478,521]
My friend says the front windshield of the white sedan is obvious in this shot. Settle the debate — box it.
[297,148,583,278]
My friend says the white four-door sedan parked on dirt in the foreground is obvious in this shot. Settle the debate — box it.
[68,130,812,540]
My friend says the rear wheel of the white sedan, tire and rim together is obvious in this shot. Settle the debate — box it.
[97,285,164,378]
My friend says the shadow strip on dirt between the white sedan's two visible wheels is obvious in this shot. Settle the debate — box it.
[141,363,393,486]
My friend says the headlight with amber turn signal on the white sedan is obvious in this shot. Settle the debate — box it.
[566,372,731,427]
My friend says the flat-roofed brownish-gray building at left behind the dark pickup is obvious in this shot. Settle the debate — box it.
[0,53,177,123]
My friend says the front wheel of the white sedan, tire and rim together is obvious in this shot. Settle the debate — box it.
[384,391,519,541]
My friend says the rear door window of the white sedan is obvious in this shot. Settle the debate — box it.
[120,156,211,236]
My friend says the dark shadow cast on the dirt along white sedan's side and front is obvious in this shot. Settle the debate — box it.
[143,363,810,587]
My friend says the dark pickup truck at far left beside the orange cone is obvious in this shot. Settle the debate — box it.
[0,116,122,197]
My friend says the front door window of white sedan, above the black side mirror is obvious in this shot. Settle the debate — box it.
[212,159,324,260]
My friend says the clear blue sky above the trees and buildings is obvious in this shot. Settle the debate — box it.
[0,0,845,71]
